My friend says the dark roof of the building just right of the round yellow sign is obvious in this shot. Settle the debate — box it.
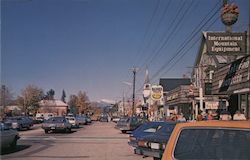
[160,78,191,92]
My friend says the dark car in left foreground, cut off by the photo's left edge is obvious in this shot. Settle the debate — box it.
[0,122,20,148]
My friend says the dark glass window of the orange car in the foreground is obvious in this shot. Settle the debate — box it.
[174,129,250,160]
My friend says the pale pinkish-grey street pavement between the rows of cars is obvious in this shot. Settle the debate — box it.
[1,122,152,160]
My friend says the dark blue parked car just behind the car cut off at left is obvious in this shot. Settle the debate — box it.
[4,116,33,130]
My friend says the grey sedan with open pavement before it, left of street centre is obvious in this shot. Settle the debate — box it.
[42,117,71,133]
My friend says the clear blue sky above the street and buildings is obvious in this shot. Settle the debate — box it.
[1,0,249,101]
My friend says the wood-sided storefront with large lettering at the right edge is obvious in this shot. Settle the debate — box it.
[212,55,250,118]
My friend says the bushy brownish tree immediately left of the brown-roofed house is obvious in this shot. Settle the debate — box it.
[17,85,44,115]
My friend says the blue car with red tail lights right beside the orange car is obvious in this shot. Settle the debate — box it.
[135,122,176,160]
